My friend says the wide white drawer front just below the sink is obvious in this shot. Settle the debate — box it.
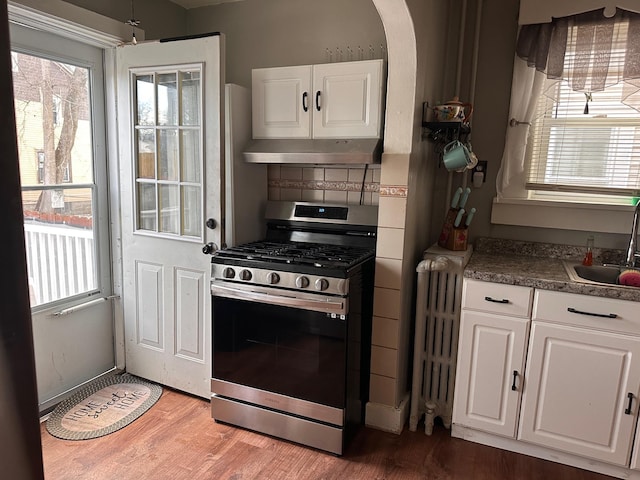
[533,290,640,334]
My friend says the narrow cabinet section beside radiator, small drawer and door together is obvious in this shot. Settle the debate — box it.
[453,279,533,437]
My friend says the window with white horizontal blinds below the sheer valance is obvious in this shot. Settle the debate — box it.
[526,16,640,203]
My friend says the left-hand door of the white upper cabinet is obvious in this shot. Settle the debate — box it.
[251,65,311,138]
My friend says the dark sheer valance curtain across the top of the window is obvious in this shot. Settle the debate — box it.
[516,9,640,104]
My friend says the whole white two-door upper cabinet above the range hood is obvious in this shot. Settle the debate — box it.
[252,60,384,138]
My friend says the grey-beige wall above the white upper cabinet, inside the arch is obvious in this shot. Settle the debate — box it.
[187,0,387,87]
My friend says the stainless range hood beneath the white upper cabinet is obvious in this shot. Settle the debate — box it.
[244,138,382,164]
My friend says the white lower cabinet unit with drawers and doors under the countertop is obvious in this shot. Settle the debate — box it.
[453,279,640,478]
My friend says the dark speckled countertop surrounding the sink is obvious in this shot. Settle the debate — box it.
[464,238,640,302]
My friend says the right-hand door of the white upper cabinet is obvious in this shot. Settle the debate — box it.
[313,60,383,138]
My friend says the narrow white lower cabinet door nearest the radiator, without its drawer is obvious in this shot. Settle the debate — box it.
[453,310,529,437]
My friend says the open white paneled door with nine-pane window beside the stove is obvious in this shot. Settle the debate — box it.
[117,36,224,398]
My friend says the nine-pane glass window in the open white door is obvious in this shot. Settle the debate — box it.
[133,67,204,239]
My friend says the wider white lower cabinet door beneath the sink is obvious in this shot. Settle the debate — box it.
[518,322,640,465]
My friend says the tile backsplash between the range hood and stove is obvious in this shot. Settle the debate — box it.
[268,164,380,205]
